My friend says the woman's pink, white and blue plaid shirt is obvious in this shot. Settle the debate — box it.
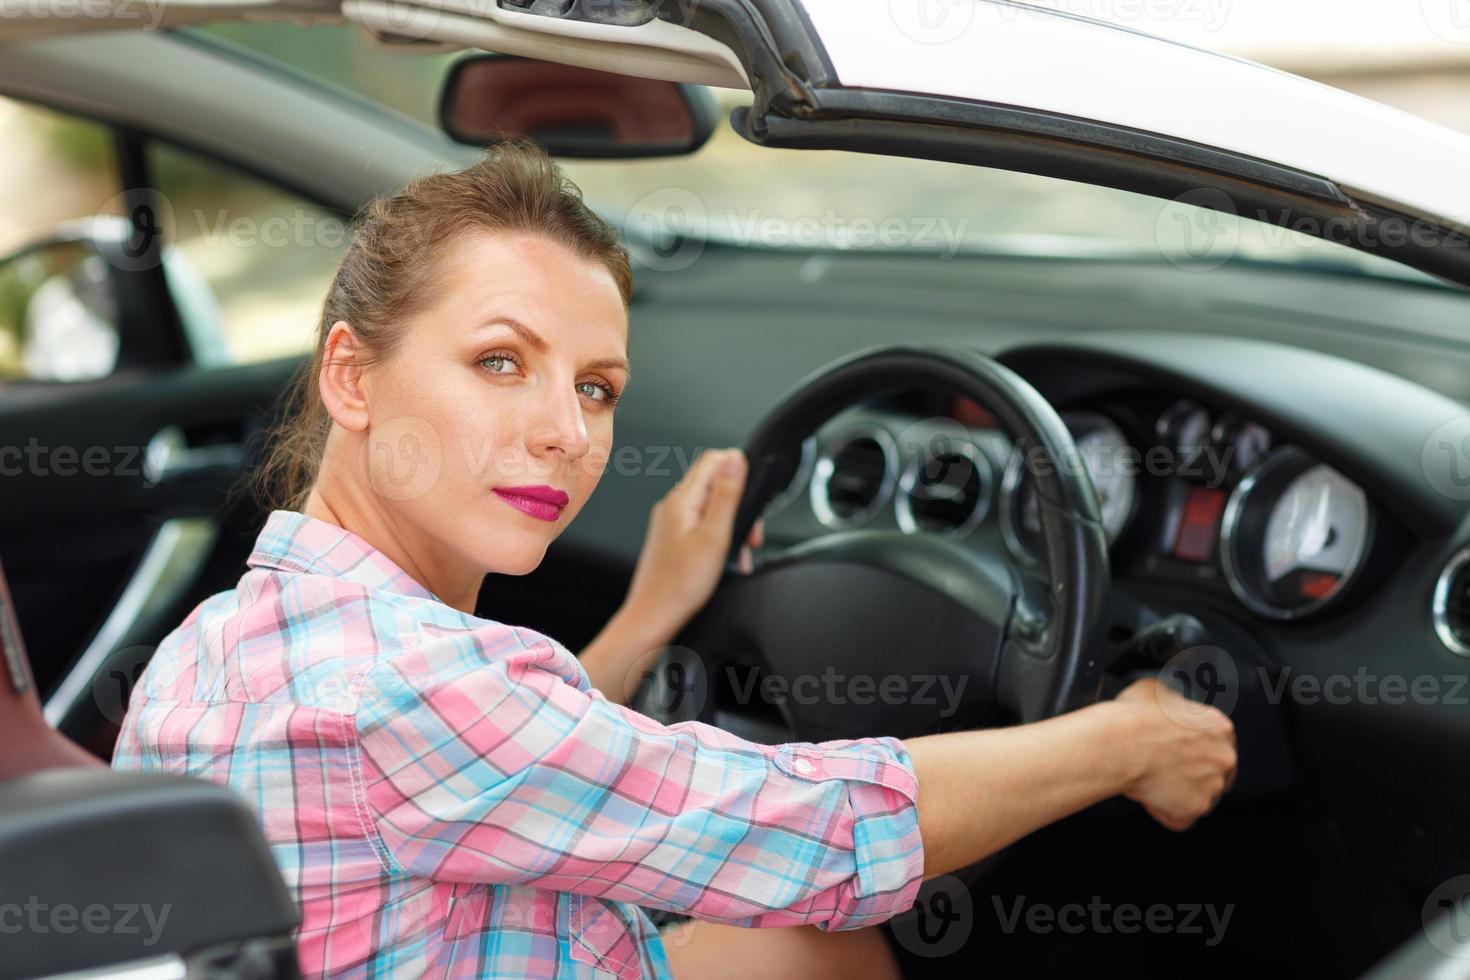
[113,510,923,977]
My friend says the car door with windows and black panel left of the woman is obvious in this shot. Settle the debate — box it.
[0,94,348,755]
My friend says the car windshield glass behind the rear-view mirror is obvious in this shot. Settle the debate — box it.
[196,24,1438,282]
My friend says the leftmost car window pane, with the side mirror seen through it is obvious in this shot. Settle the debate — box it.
[0,98,122,382]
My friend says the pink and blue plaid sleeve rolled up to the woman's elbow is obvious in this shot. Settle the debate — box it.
[354,630,923,929]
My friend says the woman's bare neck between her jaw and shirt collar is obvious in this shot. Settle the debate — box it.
[301,460,485,616]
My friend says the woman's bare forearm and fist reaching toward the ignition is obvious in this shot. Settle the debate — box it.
[904,680,1236,877]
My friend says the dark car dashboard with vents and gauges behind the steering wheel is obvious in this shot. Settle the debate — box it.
[535,251,1470,963]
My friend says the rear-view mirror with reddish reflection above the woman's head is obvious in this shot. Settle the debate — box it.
[440,54,719,159]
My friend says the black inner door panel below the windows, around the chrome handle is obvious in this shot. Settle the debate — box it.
[0,357,300,699]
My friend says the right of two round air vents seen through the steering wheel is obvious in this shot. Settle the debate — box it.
[894,439,992,535]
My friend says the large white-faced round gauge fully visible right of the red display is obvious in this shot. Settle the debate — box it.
[1220,448,1373,619]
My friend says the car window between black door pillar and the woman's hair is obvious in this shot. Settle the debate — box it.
[148,141,350,366]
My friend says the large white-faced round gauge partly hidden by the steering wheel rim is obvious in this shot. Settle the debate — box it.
[1001,411,1139,561]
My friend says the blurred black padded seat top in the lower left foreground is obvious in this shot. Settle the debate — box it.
[0,767,300,980]
